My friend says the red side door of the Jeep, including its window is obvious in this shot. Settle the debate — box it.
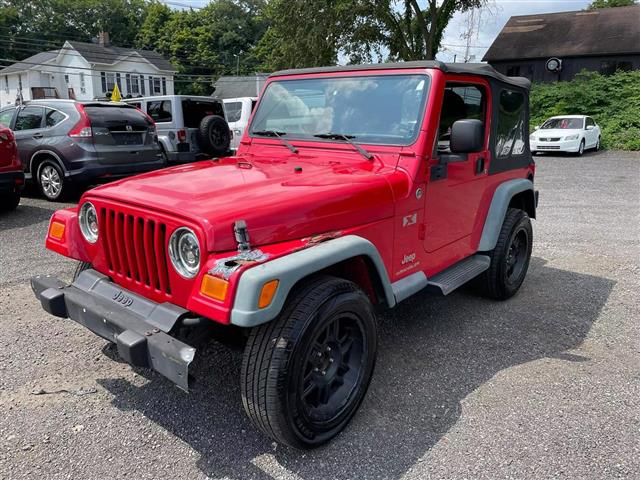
[424,81,491,255]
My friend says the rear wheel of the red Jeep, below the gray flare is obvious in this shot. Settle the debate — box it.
[479,208,533,300]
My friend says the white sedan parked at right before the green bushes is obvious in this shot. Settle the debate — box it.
[529,115,602,155]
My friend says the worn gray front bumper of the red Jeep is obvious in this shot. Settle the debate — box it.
[31,270,196,391]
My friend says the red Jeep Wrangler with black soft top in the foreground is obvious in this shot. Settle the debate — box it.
[32,62,537,447]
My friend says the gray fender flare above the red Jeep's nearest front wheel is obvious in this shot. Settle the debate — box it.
[231,235,396,327]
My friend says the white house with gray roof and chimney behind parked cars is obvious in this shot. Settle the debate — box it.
[0,32,176,107]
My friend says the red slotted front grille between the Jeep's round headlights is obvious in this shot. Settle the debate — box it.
[100,208,171,295]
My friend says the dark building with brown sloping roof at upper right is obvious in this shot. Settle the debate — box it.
[483,5,640,82]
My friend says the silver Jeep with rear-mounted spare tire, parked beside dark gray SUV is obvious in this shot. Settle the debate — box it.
[125,95,231,163]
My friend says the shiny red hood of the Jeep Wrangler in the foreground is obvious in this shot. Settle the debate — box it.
[87,155,395,251]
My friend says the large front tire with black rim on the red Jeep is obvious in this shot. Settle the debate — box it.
[241,277,377,448]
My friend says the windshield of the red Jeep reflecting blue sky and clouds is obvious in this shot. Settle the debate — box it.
[251,74,429,145]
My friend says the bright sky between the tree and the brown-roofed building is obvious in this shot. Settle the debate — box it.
[437,0,591,62]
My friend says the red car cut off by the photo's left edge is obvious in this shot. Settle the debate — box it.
[0,124,24,212]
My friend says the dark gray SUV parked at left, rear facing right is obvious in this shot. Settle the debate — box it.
[0,99,166,201]
